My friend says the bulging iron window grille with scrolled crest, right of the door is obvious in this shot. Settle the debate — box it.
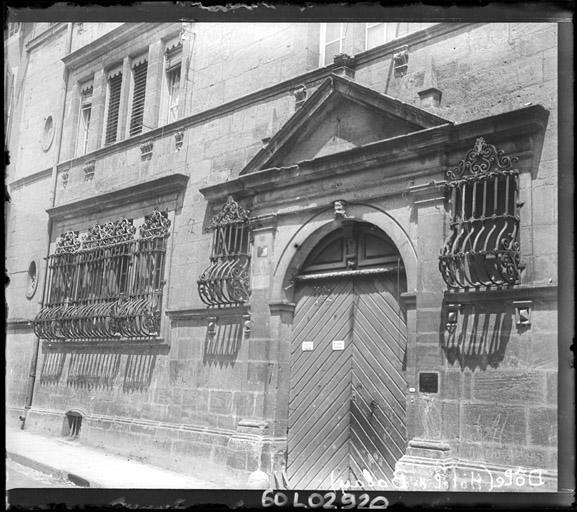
[439,137,524,289]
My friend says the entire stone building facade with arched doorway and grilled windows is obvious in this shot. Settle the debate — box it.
[5,23,558,491]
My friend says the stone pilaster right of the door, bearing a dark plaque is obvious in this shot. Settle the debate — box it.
[396,182,451,490]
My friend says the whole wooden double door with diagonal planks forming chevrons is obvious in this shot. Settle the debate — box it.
[287,273,407,489]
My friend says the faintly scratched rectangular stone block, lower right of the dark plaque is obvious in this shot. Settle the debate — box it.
[461,404,527,445]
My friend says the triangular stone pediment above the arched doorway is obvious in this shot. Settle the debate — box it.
[241,75,450,174]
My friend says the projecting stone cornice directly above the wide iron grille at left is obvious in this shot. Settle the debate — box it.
[46,174,188,220]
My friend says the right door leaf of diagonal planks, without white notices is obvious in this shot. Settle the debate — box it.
[350,275,407,489]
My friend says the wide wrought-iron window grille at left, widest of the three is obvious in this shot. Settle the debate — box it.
[34,210,171,341]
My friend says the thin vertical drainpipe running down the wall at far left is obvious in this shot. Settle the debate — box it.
[19,22,74,430]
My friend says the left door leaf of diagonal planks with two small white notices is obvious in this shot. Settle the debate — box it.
[287,280,353,489]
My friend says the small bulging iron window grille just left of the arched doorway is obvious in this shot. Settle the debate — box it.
[198,196,250,307]
